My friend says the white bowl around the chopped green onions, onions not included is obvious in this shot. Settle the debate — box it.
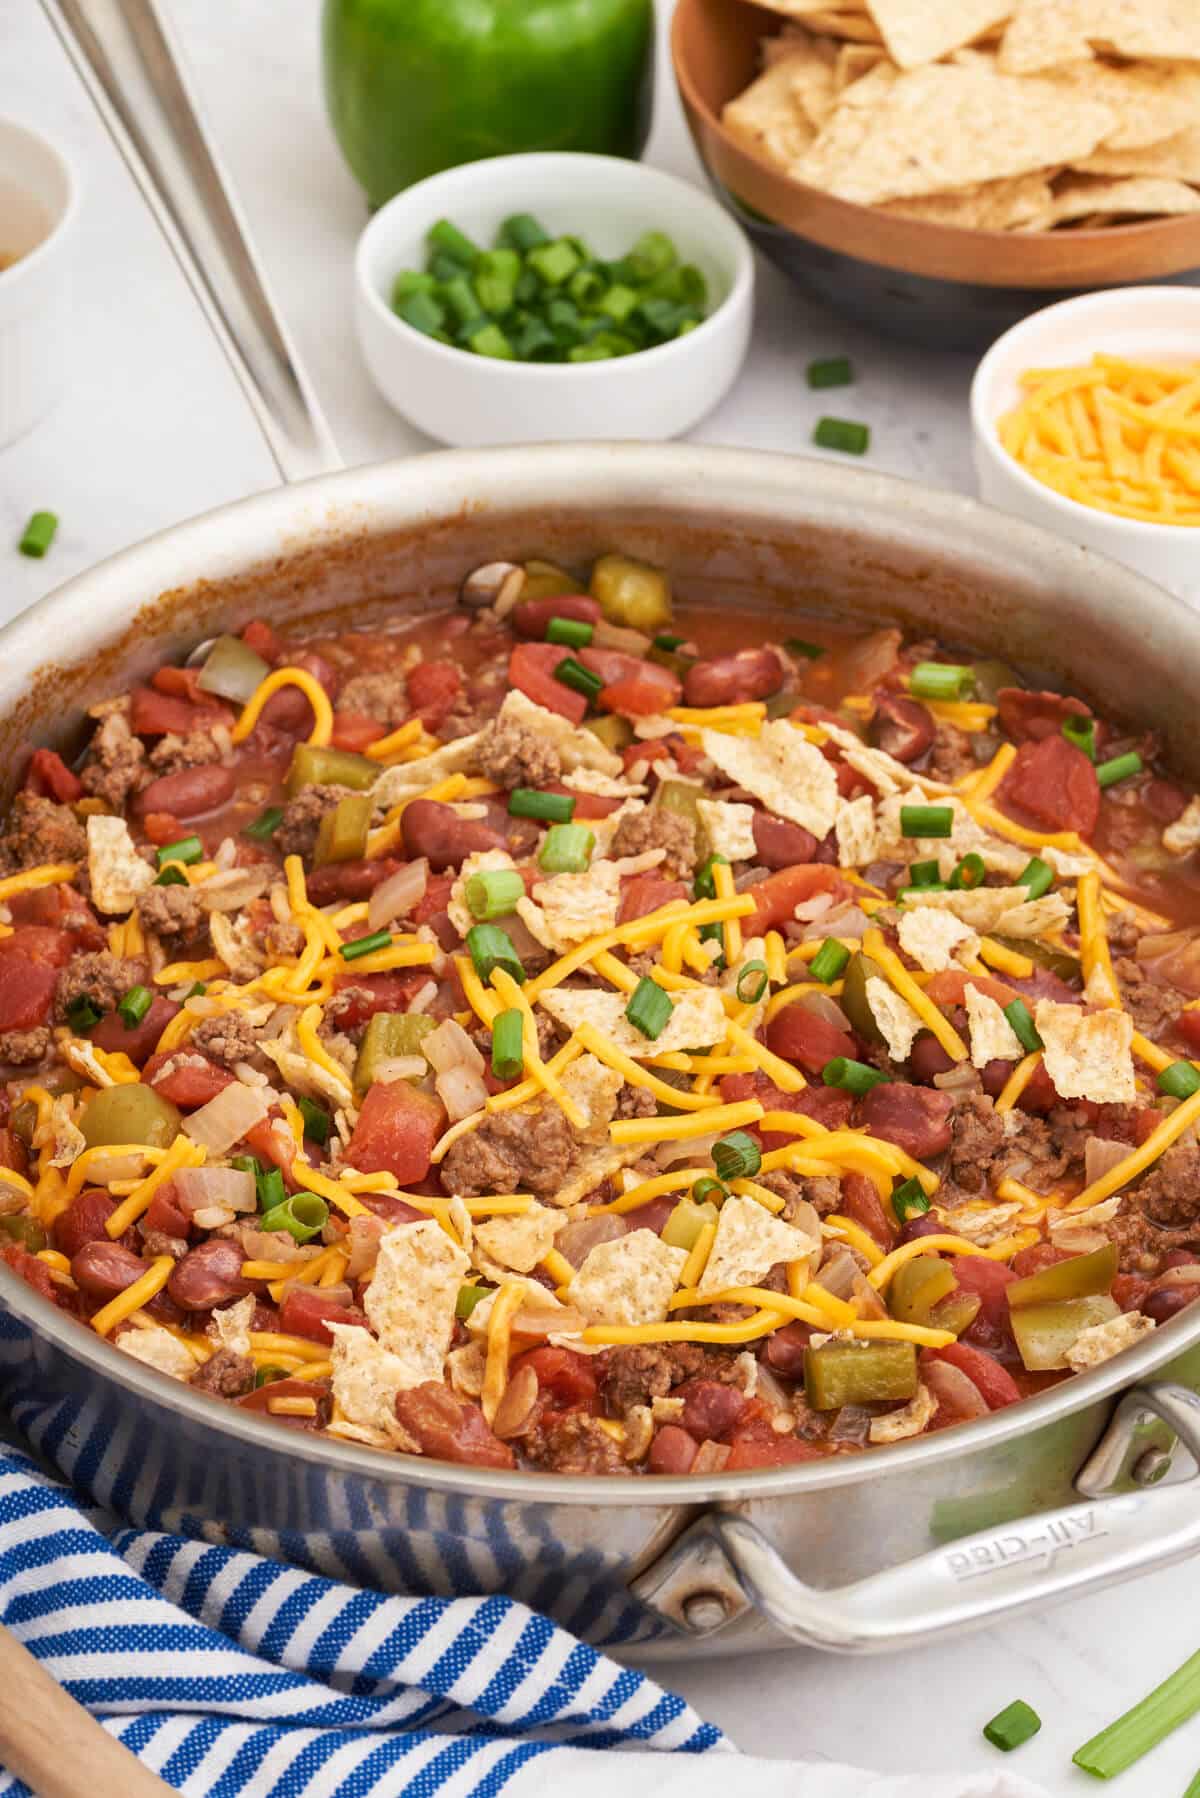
[354,153,754,448]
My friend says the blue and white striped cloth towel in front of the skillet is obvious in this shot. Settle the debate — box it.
[0,1447,1038,1798]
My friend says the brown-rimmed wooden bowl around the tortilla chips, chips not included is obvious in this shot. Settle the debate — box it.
[671,0,1200,349]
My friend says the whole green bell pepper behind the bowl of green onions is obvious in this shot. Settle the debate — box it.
[322,0,655,206]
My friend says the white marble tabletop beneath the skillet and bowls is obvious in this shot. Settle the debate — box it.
[0,0,1200,1798]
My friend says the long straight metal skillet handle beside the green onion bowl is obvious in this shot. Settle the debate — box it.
[41,0,342,482]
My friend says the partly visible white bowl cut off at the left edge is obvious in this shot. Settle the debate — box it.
[0,119,79,444]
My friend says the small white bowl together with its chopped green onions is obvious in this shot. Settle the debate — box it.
[354,153,754,446]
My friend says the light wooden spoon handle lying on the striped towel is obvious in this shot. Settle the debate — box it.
[0,1625,178,1798]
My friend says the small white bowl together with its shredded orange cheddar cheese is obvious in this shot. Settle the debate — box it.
[972,286,1200,606]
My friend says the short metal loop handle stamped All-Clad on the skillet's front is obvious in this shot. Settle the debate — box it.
[633,1384,1200,1654]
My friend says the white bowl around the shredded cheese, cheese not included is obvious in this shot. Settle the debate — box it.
[972,288,1200,606]
